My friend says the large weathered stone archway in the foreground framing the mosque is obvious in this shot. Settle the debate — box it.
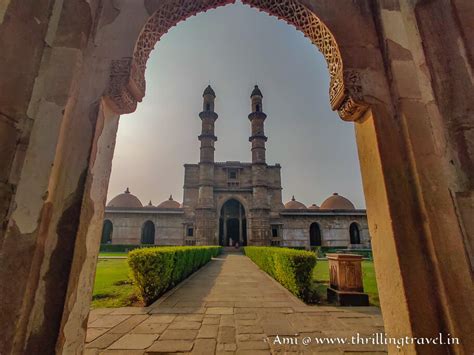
[0,0,474,354]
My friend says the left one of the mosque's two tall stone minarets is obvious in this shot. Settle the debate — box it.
[196,85,218,245]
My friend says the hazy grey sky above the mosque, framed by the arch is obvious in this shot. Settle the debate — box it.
[108,4,365,208]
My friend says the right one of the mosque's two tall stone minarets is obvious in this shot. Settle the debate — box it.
[249,85,270,245]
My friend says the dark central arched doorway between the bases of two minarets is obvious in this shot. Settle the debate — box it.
[219,199,247,246]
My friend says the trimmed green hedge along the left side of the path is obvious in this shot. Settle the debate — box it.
[128,246,222,306]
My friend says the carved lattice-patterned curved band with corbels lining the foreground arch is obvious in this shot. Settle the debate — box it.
[106,0,367,121]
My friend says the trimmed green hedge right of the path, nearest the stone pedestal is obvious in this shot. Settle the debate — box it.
[244,247,316,300]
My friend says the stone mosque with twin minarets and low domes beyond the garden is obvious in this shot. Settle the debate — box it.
[102,86,370,248]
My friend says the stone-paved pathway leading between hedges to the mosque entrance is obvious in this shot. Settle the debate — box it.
[85,254,386,355]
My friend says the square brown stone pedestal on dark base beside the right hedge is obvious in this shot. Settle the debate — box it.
[327,254,369,306]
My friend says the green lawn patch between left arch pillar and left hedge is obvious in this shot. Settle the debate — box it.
[91,259,136,308]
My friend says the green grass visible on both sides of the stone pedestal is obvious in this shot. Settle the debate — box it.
[313,260,380,307]
